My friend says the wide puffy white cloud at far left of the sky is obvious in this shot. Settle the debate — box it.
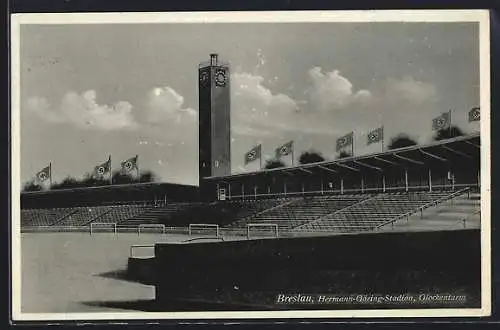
[27,90,139,130]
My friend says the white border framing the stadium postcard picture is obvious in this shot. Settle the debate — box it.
[10,10,491,321]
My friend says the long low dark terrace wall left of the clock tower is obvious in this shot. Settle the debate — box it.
[21,183,199,209]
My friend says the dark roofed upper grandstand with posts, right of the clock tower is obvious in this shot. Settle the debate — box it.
[205,133,480,200]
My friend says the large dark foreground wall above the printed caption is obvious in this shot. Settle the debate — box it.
[151,229,481,308]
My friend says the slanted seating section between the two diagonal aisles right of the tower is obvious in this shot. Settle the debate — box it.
[230,195,369,229]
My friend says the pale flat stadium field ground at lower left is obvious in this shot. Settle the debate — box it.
[21,232,186,313]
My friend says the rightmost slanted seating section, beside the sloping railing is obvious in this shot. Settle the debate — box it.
[294,192,450,232]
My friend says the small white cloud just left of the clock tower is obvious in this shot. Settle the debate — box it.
[147,86,197,123]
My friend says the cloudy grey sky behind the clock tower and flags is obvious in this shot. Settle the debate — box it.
[20,23,479,184]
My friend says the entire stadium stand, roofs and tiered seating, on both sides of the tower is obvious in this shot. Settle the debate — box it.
[21,134,480,235]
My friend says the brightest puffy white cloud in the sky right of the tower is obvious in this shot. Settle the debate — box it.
[307,67,371,112]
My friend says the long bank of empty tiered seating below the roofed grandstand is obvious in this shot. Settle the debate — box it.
[21,191,472,234]
